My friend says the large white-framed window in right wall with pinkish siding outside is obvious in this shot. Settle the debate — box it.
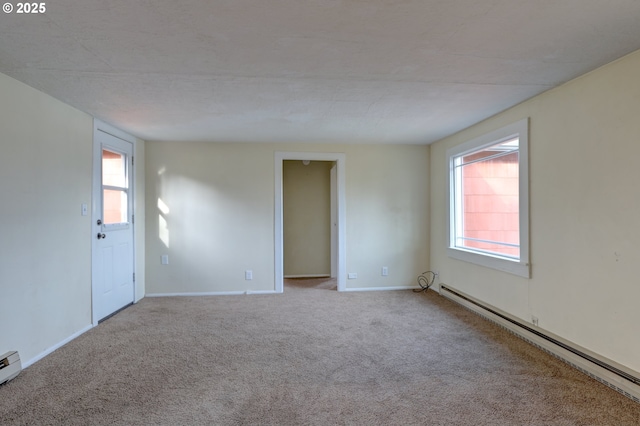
[447,119,530,277]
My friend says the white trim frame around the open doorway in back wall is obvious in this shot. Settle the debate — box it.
[274,151,347,293]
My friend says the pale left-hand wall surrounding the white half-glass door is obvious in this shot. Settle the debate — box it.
[0,74,144,364]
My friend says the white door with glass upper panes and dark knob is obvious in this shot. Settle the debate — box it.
[92,128,135,324]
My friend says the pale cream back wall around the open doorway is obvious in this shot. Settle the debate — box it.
[146,142,429,294]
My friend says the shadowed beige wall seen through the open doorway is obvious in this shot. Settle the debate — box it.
[282,160,334,277]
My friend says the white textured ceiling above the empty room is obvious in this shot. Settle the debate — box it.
[0,0,640,143]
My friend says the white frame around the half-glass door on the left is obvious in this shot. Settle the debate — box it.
[91,118,137,327]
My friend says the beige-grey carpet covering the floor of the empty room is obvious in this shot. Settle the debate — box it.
[0,280,640,425]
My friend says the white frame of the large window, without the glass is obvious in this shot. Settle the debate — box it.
[447,118,531,278]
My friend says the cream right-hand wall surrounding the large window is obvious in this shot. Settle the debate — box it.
[430,48,640,371]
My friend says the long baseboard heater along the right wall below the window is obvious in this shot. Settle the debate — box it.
[440,284,640,403]
